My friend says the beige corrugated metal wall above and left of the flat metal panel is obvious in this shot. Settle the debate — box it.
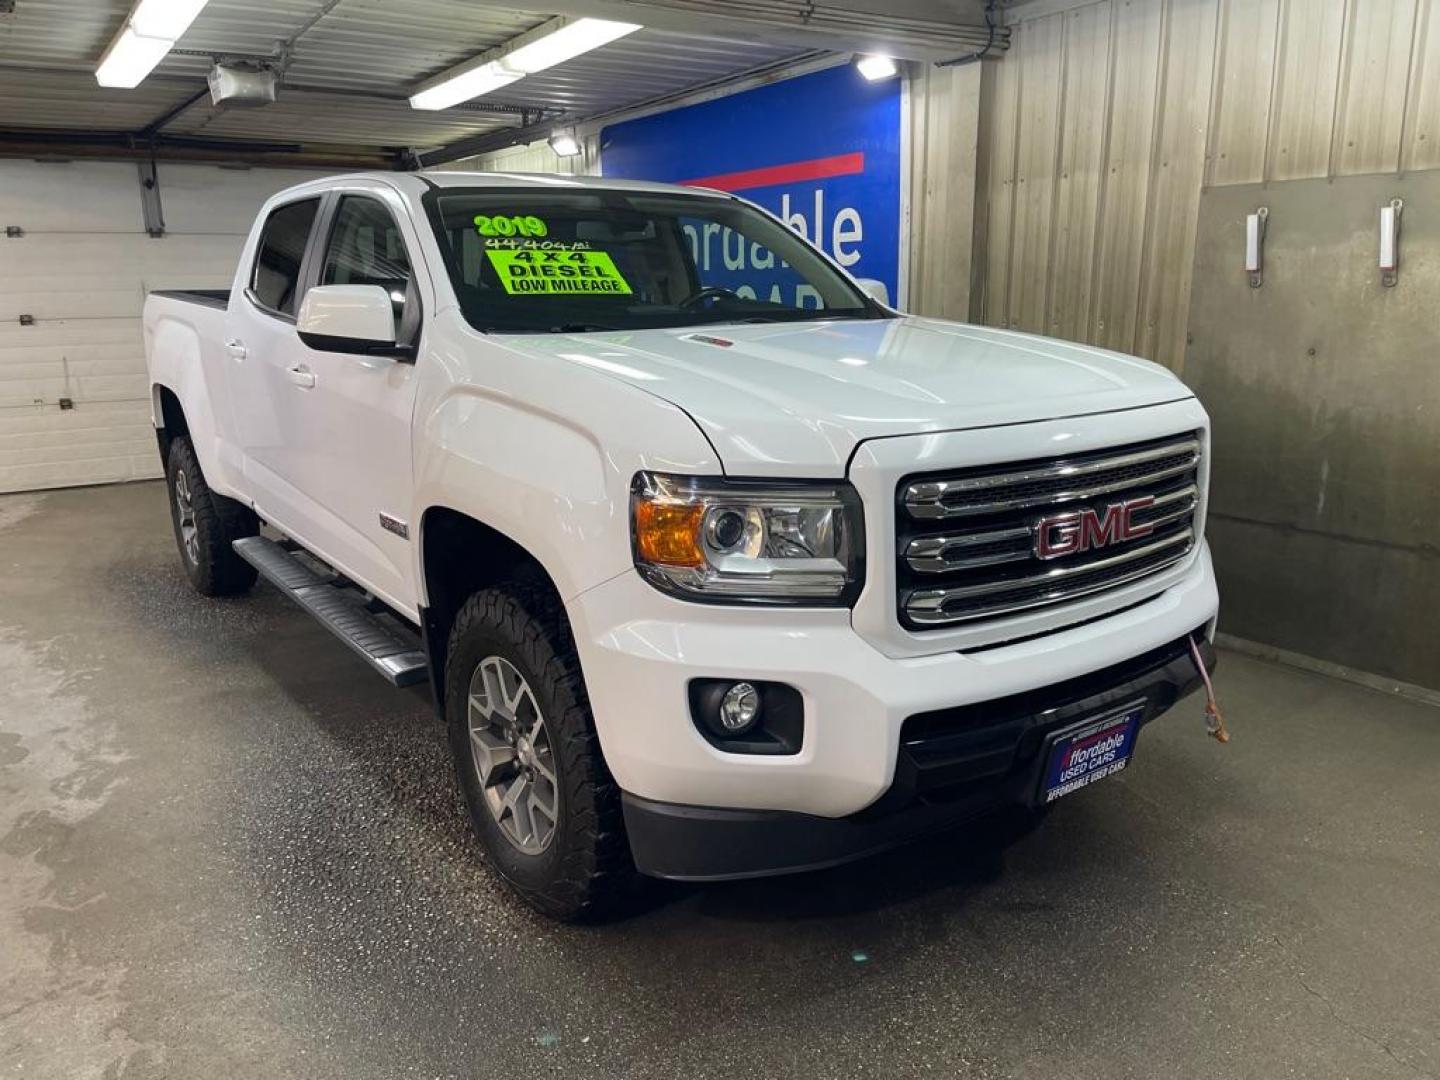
[973,0,1440,369]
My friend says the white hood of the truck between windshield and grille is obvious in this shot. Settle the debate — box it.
[508,317,1192,477]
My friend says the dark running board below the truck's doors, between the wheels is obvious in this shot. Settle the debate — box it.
[232,536,428,687]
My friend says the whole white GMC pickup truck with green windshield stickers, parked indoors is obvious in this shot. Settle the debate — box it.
[144,173,1217,917]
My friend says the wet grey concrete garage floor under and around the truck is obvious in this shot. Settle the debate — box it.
[0,484,1440,1080]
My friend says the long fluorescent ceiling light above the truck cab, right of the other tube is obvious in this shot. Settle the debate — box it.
[410,17,641,109]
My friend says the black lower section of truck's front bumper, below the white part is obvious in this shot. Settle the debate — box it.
[624,639,1215,881]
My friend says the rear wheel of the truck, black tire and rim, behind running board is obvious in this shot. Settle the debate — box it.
[166,435,261,596]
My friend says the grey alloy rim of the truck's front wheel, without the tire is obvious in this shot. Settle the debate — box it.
[467,657,560,855]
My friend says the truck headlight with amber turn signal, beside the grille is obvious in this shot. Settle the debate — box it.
[631,472,864,606]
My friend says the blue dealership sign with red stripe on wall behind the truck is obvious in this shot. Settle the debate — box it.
[600,63,900,300]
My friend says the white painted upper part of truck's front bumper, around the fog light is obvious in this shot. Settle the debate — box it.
[567,546,1218,818]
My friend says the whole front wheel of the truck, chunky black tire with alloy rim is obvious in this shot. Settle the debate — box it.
[445,582,638,920]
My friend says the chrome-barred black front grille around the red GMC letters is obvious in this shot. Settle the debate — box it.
[896,432,1201,629]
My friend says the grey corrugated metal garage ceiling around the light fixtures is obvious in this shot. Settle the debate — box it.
[0,0,1008,164]
